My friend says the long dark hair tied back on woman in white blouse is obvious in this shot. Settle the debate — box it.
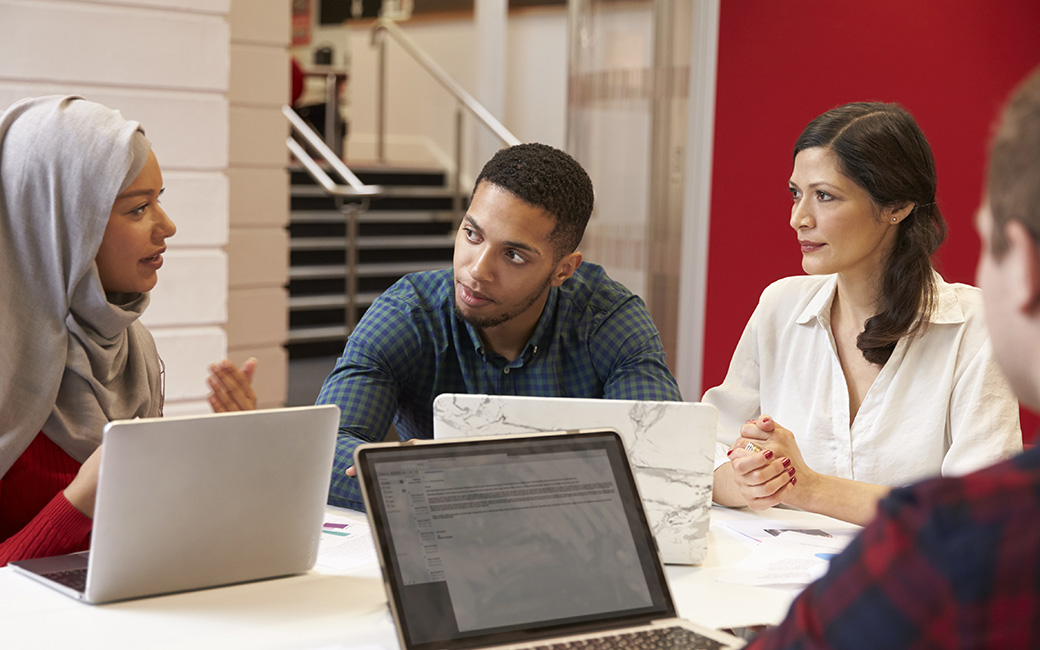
[795,103,946,365]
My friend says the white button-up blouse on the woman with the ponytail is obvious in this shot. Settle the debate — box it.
[703,274,1022,486]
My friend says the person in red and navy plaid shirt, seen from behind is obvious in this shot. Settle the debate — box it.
[748,63,1040,650]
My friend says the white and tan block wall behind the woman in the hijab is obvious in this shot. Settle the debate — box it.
[0,0,289,415]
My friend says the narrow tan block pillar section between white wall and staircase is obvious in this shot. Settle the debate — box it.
[227,0,289,407]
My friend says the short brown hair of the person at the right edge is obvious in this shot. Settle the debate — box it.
[987,68,1040,259]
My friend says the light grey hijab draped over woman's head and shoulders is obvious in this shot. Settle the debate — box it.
[0,96,162,476]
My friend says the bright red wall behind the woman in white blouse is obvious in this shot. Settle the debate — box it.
[703,0,1040,440]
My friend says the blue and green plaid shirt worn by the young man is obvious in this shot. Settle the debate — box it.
[317,262,682,510]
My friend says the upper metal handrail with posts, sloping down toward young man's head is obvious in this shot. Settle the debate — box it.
[371,17,520,213]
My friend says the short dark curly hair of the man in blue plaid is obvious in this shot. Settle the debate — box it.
[471,142,593,260]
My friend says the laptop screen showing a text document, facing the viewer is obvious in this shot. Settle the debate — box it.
[357,432,674,650]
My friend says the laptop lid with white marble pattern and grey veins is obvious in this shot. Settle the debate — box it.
[434,393,719,565]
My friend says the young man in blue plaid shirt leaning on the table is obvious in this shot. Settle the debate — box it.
[317,144,681,510]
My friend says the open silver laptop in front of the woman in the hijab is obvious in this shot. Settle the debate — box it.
[10,406,339,603]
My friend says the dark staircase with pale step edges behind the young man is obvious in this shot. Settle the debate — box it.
[287,163,460,366]
